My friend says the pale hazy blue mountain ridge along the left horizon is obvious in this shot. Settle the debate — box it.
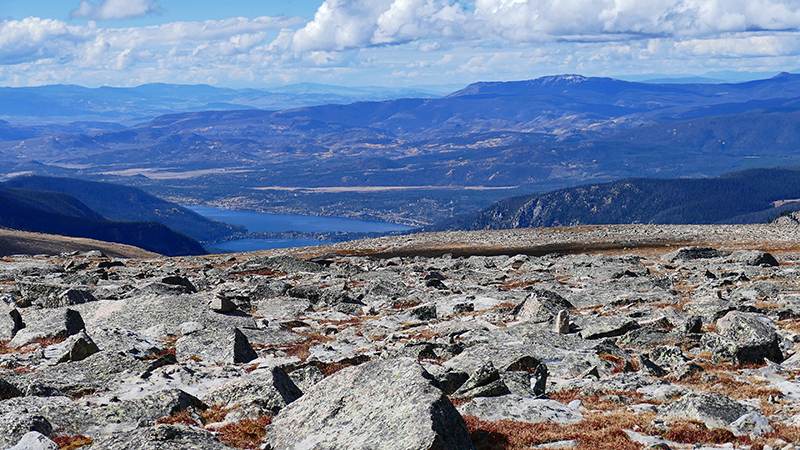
[0,83,445,125]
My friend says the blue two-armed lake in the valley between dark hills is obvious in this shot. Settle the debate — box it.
[187,206,414,252]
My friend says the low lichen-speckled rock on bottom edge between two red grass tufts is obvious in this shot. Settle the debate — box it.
[89,425,234,450]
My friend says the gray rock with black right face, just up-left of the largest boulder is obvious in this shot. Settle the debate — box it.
[203,367,303,413]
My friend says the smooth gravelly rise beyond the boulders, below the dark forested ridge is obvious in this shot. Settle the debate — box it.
[253,225,800,259]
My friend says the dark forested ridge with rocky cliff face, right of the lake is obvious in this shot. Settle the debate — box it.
[426,166,800,231]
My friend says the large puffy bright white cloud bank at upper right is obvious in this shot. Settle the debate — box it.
[293,0,800,51]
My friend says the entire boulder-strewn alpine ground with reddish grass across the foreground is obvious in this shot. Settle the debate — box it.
[0,224,800,450]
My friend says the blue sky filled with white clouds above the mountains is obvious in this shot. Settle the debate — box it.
[0,0,800,89]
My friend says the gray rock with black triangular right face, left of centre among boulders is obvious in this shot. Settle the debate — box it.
[175,328,258,364]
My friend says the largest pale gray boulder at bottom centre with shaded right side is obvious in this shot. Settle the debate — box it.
[267,358,473,450]
